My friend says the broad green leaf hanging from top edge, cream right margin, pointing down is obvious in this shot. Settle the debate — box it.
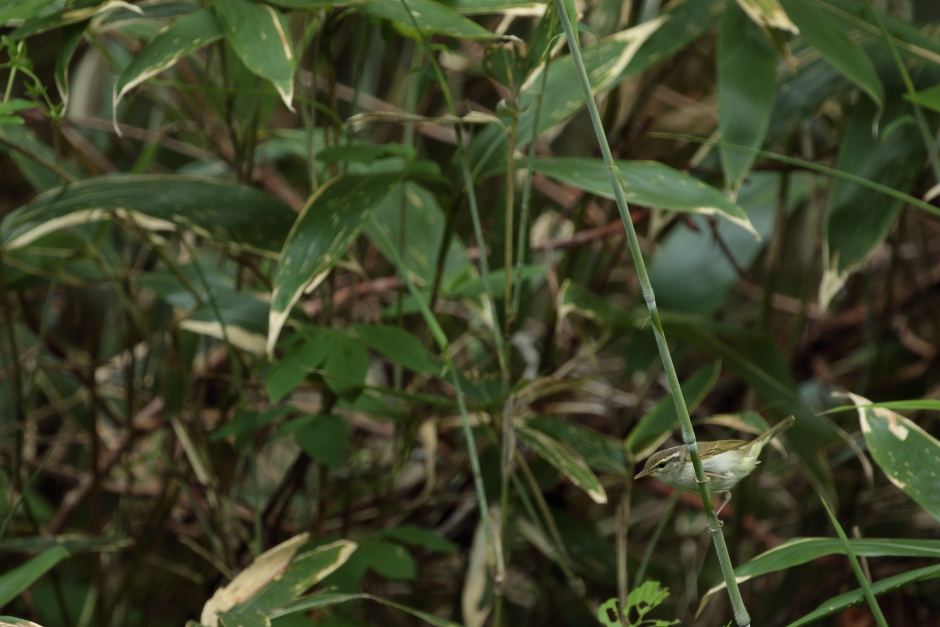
[214,0,296,111]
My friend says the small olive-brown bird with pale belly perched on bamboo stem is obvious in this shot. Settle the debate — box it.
[634,416,794,515]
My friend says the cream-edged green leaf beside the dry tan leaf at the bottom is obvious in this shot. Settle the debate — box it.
[233,540,357,614]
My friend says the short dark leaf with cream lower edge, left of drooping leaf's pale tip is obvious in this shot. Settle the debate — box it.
[179,292,268,355]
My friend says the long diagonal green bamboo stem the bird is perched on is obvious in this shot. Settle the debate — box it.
[555,0,751,627]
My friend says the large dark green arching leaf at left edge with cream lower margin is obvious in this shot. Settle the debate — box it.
[0,175,297,255]
